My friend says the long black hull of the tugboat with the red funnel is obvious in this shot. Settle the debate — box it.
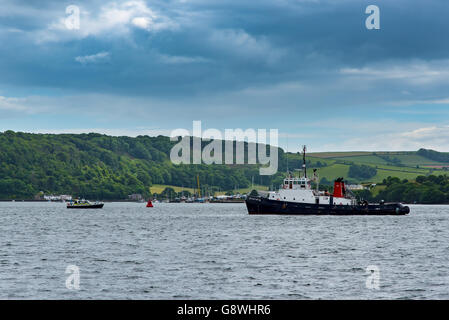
[245,197,410,216]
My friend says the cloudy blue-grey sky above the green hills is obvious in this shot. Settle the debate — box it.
[0,0,449,151]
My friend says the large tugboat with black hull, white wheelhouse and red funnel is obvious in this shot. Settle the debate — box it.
[245,146,410,216]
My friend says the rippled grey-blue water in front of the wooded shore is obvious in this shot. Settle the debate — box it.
[0,202,449,299]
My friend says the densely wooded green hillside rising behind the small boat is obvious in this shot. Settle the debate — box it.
[0,131,285,199]
